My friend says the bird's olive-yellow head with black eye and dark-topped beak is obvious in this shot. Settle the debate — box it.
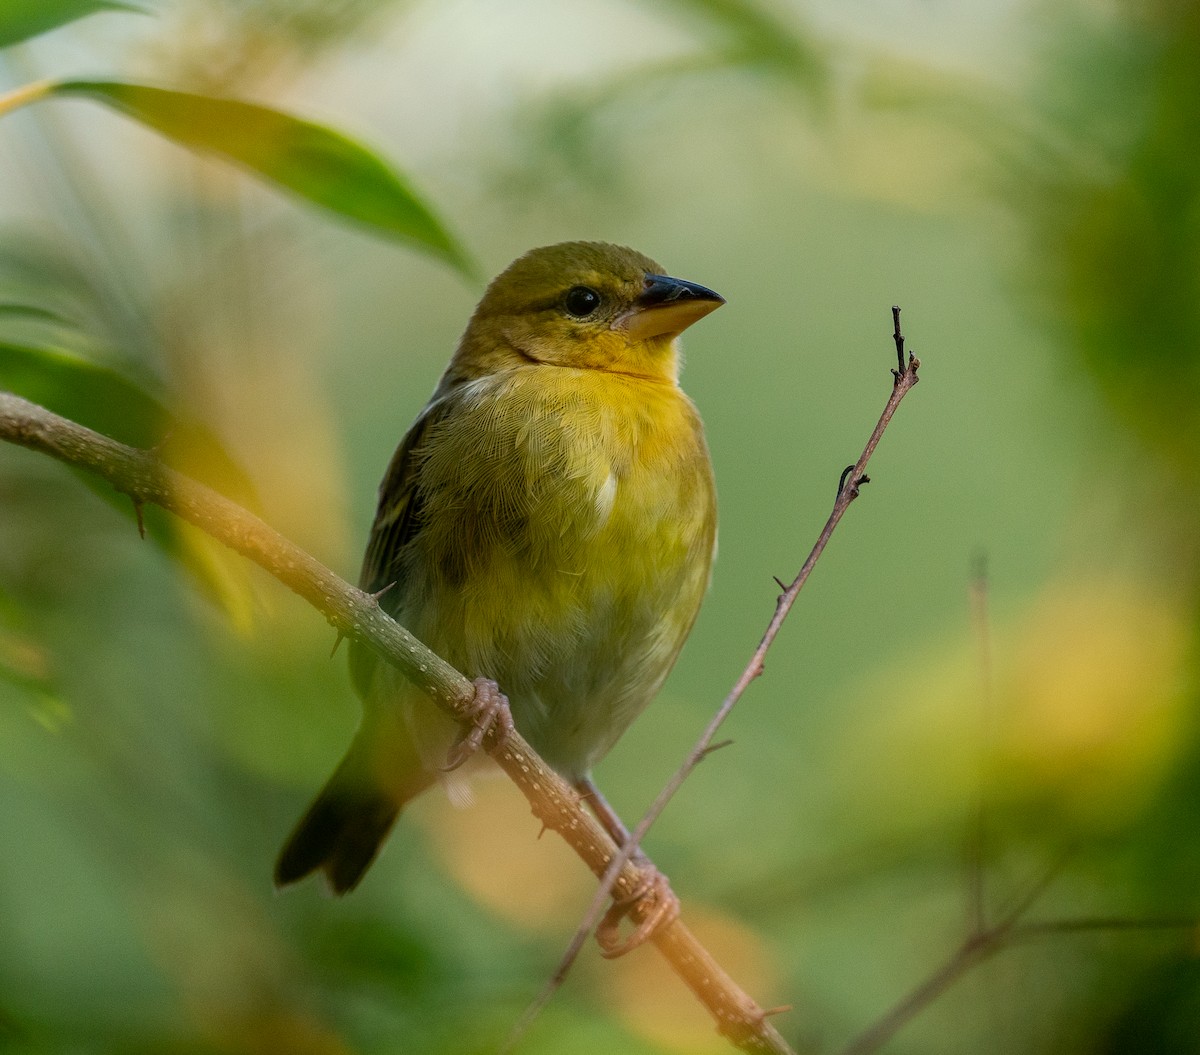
[456,241,725,382]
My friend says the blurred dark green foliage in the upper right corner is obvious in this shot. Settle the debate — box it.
[1027,2,1200,490]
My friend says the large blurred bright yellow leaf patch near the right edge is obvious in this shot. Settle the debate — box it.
[830,577,1193,833]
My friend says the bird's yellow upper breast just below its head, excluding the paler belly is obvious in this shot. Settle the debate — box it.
[418,367,713,579]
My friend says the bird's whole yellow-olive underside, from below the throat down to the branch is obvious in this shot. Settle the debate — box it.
[402,367,716,773]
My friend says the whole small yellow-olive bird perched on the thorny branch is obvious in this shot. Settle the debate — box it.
[275,241,725,893]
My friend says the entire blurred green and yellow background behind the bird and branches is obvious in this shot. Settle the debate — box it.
[0,0,1200,1055]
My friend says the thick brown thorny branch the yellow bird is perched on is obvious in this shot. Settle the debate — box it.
[0,391,791,1055]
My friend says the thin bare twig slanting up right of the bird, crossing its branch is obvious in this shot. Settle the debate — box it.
[513,307,920,1050]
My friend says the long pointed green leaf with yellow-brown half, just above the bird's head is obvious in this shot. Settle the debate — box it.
[50,80,478,278]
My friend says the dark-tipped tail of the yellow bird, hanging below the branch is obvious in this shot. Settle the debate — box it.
[275,721,434,894]
